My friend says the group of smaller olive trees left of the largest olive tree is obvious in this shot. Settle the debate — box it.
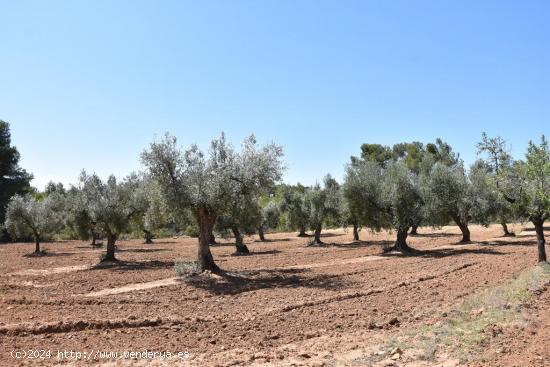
[5,172,167,261]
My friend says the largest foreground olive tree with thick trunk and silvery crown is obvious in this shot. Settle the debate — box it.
[141,134,283,272]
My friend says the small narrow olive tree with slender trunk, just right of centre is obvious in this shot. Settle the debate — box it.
[305,175,341,246]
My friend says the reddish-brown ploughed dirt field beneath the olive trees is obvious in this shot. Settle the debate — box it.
[0,225,550,367]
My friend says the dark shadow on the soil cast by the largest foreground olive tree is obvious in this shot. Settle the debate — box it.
[187,269,346,295]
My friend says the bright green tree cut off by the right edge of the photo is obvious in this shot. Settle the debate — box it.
[501,135,550,262]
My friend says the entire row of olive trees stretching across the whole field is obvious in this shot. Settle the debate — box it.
[2,134,550,271]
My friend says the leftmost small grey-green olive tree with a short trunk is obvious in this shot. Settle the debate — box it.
[4,194,63,254]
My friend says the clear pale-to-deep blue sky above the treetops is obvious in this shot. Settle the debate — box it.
[0,0,550,188]
